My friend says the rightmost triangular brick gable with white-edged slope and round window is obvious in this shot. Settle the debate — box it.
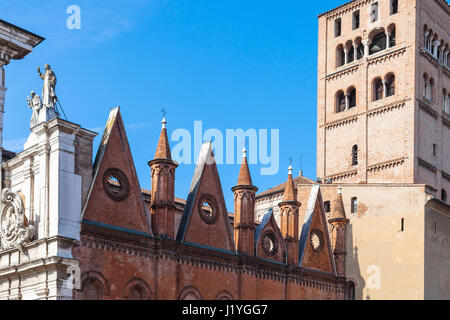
[299,185,336,274]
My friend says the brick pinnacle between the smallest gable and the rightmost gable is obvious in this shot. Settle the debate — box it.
[278,166,301,265]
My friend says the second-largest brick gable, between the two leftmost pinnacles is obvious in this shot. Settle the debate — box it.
[177,142,235,251]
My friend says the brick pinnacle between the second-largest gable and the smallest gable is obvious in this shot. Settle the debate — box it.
[231,148,258,255]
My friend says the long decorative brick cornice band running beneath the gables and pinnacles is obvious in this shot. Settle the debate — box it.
[80,224,345,292]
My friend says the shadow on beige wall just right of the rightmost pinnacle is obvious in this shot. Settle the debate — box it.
[347,223,370,300]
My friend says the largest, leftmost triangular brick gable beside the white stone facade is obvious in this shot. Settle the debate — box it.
[82,108,151,233]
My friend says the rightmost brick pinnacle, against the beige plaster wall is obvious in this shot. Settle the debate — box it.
[328,188,349,276]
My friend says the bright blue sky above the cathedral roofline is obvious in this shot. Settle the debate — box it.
[0,0,343,211]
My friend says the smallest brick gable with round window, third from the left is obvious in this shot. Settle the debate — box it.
[255,209,286,263]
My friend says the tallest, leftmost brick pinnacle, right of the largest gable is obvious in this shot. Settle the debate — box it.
[148,118,178,239]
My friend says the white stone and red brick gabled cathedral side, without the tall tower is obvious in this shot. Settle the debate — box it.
[0,21,347,300]
